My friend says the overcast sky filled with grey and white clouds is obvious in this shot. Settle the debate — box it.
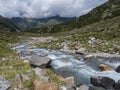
[0,0,107,18]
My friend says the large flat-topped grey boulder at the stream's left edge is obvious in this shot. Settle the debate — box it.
[30,55,51,68]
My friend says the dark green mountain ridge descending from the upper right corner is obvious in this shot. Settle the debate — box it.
[27,0,120,33]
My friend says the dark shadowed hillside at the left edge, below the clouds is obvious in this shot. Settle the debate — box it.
[0,16,20,32]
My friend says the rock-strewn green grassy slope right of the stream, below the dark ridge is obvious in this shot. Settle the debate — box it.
[37,16,120,53]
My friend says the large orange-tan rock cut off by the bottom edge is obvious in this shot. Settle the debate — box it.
[33,80,58,90]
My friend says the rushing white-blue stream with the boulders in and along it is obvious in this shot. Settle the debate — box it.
[9,43,120,90]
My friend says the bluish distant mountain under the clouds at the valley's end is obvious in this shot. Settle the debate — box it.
[10,15,75,30]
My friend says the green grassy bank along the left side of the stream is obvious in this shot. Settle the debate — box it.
[0,33,38,90]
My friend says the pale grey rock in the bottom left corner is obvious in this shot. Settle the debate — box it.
[0,77,11,90]
